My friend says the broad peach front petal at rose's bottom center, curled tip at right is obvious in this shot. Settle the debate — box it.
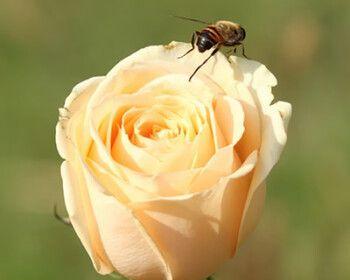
[133,151,256,280]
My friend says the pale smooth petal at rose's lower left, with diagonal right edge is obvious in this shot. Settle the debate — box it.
[81,159,171,280]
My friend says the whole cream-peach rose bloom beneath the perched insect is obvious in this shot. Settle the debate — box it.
[56,43,291,280]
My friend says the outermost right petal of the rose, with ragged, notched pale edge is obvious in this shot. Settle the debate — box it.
[230,57,291,242]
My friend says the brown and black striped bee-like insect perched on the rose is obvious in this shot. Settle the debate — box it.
[175,16,247,81]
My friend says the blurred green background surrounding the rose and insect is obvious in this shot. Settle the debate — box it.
[0,0,350,280]
